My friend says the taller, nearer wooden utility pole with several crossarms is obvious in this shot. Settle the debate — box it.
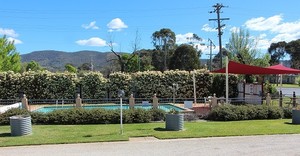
[209,3,229,68]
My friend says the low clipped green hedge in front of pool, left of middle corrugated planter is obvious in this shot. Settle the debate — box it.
[0,108,165,125]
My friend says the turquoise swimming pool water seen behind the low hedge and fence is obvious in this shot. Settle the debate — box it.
[35,104,184,113]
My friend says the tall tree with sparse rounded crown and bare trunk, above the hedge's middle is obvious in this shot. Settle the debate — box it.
[152,28,176,70]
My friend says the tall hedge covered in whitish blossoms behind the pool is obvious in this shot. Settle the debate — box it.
[0,70,238,99]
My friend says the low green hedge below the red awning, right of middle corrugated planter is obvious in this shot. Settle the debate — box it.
[208,105,291,121]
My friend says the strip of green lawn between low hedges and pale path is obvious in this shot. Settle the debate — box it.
[0,119,300,146]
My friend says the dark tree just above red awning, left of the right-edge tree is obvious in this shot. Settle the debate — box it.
[268,41,287,65]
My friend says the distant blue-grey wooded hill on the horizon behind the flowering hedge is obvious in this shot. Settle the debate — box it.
[21,50,114,71]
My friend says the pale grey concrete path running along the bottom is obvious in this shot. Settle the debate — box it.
[0,134,300,156]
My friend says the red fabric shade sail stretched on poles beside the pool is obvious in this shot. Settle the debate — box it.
[211,61,300,75]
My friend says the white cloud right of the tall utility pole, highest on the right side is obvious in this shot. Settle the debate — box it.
[245,15,282,31]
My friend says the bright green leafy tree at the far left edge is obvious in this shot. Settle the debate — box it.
[0,36,21,72]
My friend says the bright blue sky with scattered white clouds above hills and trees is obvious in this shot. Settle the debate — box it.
[0,0,300,58]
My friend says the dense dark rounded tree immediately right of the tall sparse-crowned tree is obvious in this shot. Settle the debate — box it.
[170,44,200,71]
